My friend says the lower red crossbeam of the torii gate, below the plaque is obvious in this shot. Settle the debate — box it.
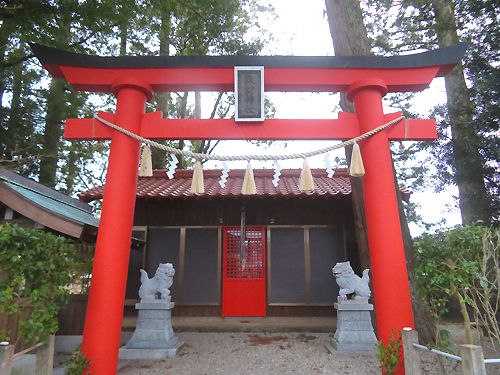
[64,112,437,141]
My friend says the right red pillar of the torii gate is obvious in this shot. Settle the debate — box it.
[348,79,414,368]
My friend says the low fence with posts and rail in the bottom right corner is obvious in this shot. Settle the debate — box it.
[401,328,500,375]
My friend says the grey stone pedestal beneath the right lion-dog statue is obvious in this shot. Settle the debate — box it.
[332,299,377,352]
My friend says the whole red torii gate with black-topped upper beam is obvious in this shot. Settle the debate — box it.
[31,44,465,375]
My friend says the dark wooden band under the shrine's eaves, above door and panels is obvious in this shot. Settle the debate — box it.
[134,196,353,226]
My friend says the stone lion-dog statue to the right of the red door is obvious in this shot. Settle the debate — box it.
[332,262,371,301]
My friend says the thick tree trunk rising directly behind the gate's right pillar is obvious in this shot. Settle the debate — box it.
[325,0,436,342]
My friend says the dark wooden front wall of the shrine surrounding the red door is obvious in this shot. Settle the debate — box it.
[120,196,359,316]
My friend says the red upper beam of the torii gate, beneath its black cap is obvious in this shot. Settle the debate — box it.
[60,66,439,92]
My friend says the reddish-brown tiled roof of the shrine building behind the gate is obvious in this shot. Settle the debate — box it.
[79,169,358,202]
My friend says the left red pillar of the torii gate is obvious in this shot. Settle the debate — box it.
[82,80,151,375]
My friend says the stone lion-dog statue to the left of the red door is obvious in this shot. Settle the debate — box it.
[139,263,175,302]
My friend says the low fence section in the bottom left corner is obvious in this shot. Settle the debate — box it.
[0,335,55,375]
